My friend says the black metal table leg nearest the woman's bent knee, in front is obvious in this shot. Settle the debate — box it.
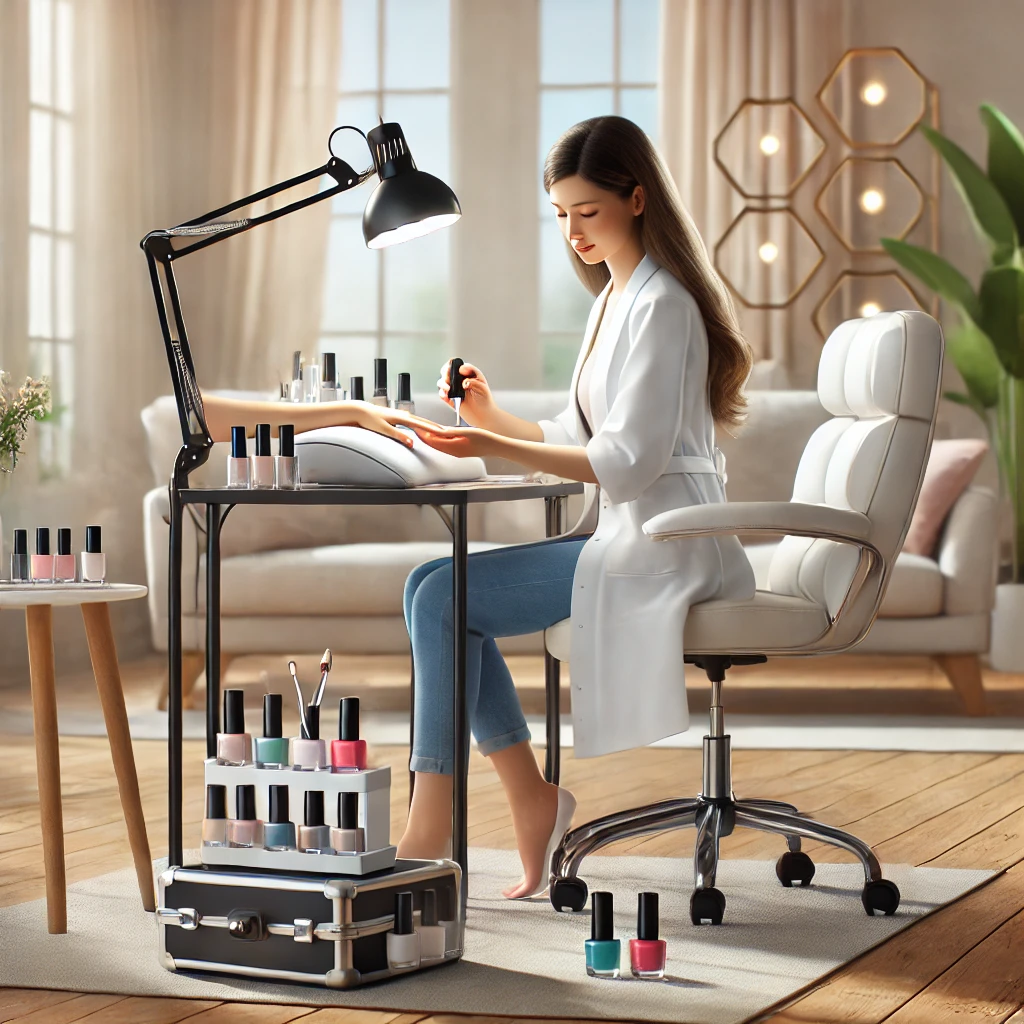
[452,503,469,910]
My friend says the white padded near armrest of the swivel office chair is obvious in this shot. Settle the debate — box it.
[643,502,873,550]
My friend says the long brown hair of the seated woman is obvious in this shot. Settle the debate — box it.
[544,115,754,427]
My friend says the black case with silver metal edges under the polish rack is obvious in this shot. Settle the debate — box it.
[157,860,463,988]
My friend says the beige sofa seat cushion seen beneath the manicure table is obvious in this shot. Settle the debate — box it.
[206,541,501,617]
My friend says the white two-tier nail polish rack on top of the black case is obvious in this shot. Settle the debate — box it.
[200,758,397,877]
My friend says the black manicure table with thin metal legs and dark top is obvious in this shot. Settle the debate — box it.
[162,479,584,905]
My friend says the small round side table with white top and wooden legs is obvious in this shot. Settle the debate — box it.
[0,583,157,934]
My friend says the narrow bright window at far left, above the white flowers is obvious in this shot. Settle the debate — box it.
[28,0,74,476]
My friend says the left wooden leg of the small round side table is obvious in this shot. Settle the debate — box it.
[25,604,68,935]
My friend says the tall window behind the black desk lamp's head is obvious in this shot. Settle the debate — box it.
[321,0,451,397]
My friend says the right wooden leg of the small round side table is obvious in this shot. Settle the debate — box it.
[82,603,157,910]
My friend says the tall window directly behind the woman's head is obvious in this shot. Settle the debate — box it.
[538,0,659,388]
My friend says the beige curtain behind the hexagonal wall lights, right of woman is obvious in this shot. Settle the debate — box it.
[659,0,844,387]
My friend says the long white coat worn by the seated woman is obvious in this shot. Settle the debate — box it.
[541,256,755,757]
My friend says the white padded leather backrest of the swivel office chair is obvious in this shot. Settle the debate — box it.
[768,311,943,641]
